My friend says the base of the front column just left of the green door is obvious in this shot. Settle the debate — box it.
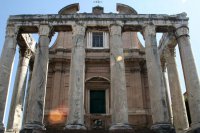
[64,124,87,133]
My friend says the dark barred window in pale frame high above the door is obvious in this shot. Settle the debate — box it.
[92,32,103,47]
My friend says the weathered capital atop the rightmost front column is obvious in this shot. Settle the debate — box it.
[175,25,189,39]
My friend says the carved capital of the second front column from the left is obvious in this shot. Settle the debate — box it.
[38,25,52,37]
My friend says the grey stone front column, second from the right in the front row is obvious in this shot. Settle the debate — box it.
[143,25,174,133]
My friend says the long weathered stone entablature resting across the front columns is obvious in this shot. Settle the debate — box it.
[8,13,189,33]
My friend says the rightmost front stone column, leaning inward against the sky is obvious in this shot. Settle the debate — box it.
[175,26,200,133]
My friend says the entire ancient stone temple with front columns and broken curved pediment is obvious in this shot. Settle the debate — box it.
[0,3,200,133]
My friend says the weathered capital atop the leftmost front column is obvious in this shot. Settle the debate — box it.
[6,25,19,37]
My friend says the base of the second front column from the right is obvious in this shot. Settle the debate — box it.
[151,123,176,133]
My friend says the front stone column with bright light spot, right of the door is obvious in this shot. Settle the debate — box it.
[110,25,131,130]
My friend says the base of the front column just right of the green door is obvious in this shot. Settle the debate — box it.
[109,123,134,133]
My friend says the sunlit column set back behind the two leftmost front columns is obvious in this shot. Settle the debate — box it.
[6,49,31,132]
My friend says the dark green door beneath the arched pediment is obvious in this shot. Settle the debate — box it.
[90,90,106,114]
